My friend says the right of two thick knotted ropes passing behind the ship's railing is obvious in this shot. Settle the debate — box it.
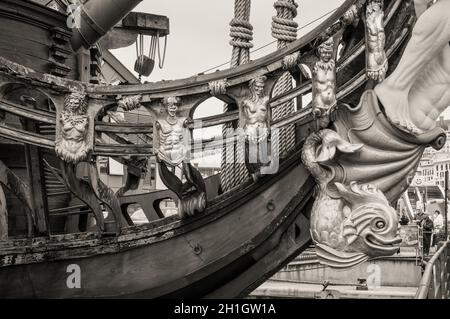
[272,0,298,158]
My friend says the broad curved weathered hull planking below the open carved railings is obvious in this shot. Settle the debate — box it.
[0,149,314,298]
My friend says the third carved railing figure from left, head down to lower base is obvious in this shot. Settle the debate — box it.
[239,76,272,180]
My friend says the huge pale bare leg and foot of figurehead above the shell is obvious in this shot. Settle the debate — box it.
[375,0,450,135]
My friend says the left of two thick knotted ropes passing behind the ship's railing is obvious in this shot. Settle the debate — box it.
[221,0,253,191]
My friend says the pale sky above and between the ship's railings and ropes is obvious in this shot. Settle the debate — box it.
[112,0,344,166]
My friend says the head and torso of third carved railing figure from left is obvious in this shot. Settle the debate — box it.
[242,76,270,143]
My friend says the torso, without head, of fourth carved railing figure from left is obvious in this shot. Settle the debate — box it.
[312,61,336,113]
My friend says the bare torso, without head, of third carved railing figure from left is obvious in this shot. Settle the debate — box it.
[242,97,270,141]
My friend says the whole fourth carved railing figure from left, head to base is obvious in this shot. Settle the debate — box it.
[312,38,337,128]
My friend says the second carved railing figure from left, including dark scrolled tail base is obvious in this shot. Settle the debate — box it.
[154,97,206,218]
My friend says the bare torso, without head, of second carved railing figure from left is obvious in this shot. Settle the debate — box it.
[157,119,188,166]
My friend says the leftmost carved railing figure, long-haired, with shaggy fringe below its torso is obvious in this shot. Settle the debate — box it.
[55,91,92,164]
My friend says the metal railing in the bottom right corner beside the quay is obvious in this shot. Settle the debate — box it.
[415,240,450,299]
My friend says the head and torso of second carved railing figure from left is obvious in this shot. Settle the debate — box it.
[155,97,189,166]
